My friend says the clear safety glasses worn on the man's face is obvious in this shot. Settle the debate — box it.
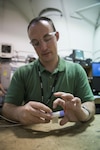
[30,31,57,47]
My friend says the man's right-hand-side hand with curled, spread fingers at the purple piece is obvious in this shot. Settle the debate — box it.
[53,92,88,125]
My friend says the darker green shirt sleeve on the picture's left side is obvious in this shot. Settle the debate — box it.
[5,67,25,106]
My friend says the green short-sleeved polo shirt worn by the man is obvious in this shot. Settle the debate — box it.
[5,58,94,110]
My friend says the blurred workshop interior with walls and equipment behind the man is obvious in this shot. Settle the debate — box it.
[0,0,100,114]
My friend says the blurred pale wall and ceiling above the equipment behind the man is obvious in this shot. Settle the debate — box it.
[0,0,100,61]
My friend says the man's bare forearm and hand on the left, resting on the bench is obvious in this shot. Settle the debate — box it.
[2,101,52,125]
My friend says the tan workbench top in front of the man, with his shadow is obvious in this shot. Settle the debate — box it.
[0,114,100,150]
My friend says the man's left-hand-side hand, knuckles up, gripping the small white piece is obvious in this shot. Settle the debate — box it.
[20,101,52,124]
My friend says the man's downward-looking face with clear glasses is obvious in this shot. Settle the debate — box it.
[28,21,59,62]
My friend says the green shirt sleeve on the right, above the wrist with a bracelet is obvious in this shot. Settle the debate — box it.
[74,64,94,102]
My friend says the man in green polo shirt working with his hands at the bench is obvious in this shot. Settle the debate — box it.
[2,17,95,125]
